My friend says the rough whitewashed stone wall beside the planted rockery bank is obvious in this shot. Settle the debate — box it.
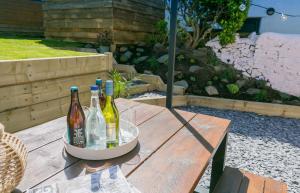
[207,33,300,97]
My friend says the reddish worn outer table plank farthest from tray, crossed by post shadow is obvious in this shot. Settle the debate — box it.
[128,114,230,193]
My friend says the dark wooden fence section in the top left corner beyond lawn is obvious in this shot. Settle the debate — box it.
[0,0,43,34]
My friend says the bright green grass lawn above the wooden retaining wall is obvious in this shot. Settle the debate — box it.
[0,34,93,60]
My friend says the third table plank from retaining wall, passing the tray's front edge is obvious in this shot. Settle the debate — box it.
[35,109,195,188]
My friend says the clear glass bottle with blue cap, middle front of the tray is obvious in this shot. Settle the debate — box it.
[86,85,106,149]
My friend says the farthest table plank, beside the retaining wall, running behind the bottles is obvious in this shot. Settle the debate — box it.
[16,99,140,152]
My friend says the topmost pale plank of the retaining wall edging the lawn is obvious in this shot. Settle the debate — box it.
[0,54,112,87]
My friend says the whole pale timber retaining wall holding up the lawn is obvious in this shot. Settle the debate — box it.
[0,53,112,132]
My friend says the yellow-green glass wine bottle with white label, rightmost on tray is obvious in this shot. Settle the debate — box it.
[103,80,119,148]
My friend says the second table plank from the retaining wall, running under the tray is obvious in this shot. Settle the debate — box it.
[18,102,164,191]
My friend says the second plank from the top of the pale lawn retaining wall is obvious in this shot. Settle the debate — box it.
[0,72,108,112]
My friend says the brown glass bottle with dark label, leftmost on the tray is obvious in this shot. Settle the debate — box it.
[67,86,86,148]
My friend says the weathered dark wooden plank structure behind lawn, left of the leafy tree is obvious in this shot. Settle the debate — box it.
[43,0,165,44]
